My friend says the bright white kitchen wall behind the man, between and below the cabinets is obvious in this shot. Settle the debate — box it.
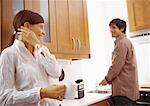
[59,0,150,90]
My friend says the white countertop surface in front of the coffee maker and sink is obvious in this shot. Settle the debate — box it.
[61,93,111,106]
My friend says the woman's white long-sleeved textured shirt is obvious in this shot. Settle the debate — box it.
[0,40,61,106]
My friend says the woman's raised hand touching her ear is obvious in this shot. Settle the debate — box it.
[17,26,40,47]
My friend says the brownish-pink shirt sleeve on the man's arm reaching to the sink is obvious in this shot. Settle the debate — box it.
[105,43,127,83]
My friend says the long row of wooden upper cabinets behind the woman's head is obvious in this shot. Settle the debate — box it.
[2,0,90,59]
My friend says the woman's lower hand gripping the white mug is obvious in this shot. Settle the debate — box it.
[40,85,65,100]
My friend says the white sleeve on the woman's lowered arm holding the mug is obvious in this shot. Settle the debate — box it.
[0,52,41,106]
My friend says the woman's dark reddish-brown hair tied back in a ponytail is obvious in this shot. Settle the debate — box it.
[12,10,44,43]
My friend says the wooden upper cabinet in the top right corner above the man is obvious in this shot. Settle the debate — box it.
[127,0,150,32]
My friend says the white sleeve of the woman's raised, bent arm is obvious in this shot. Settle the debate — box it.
[34,45,62,78]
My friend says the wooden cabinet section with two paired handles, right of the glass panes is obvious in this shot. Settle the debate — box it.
[56,0,90,59]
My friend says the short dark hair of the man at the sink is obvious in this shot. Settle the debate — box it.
[109,18,126,34]
